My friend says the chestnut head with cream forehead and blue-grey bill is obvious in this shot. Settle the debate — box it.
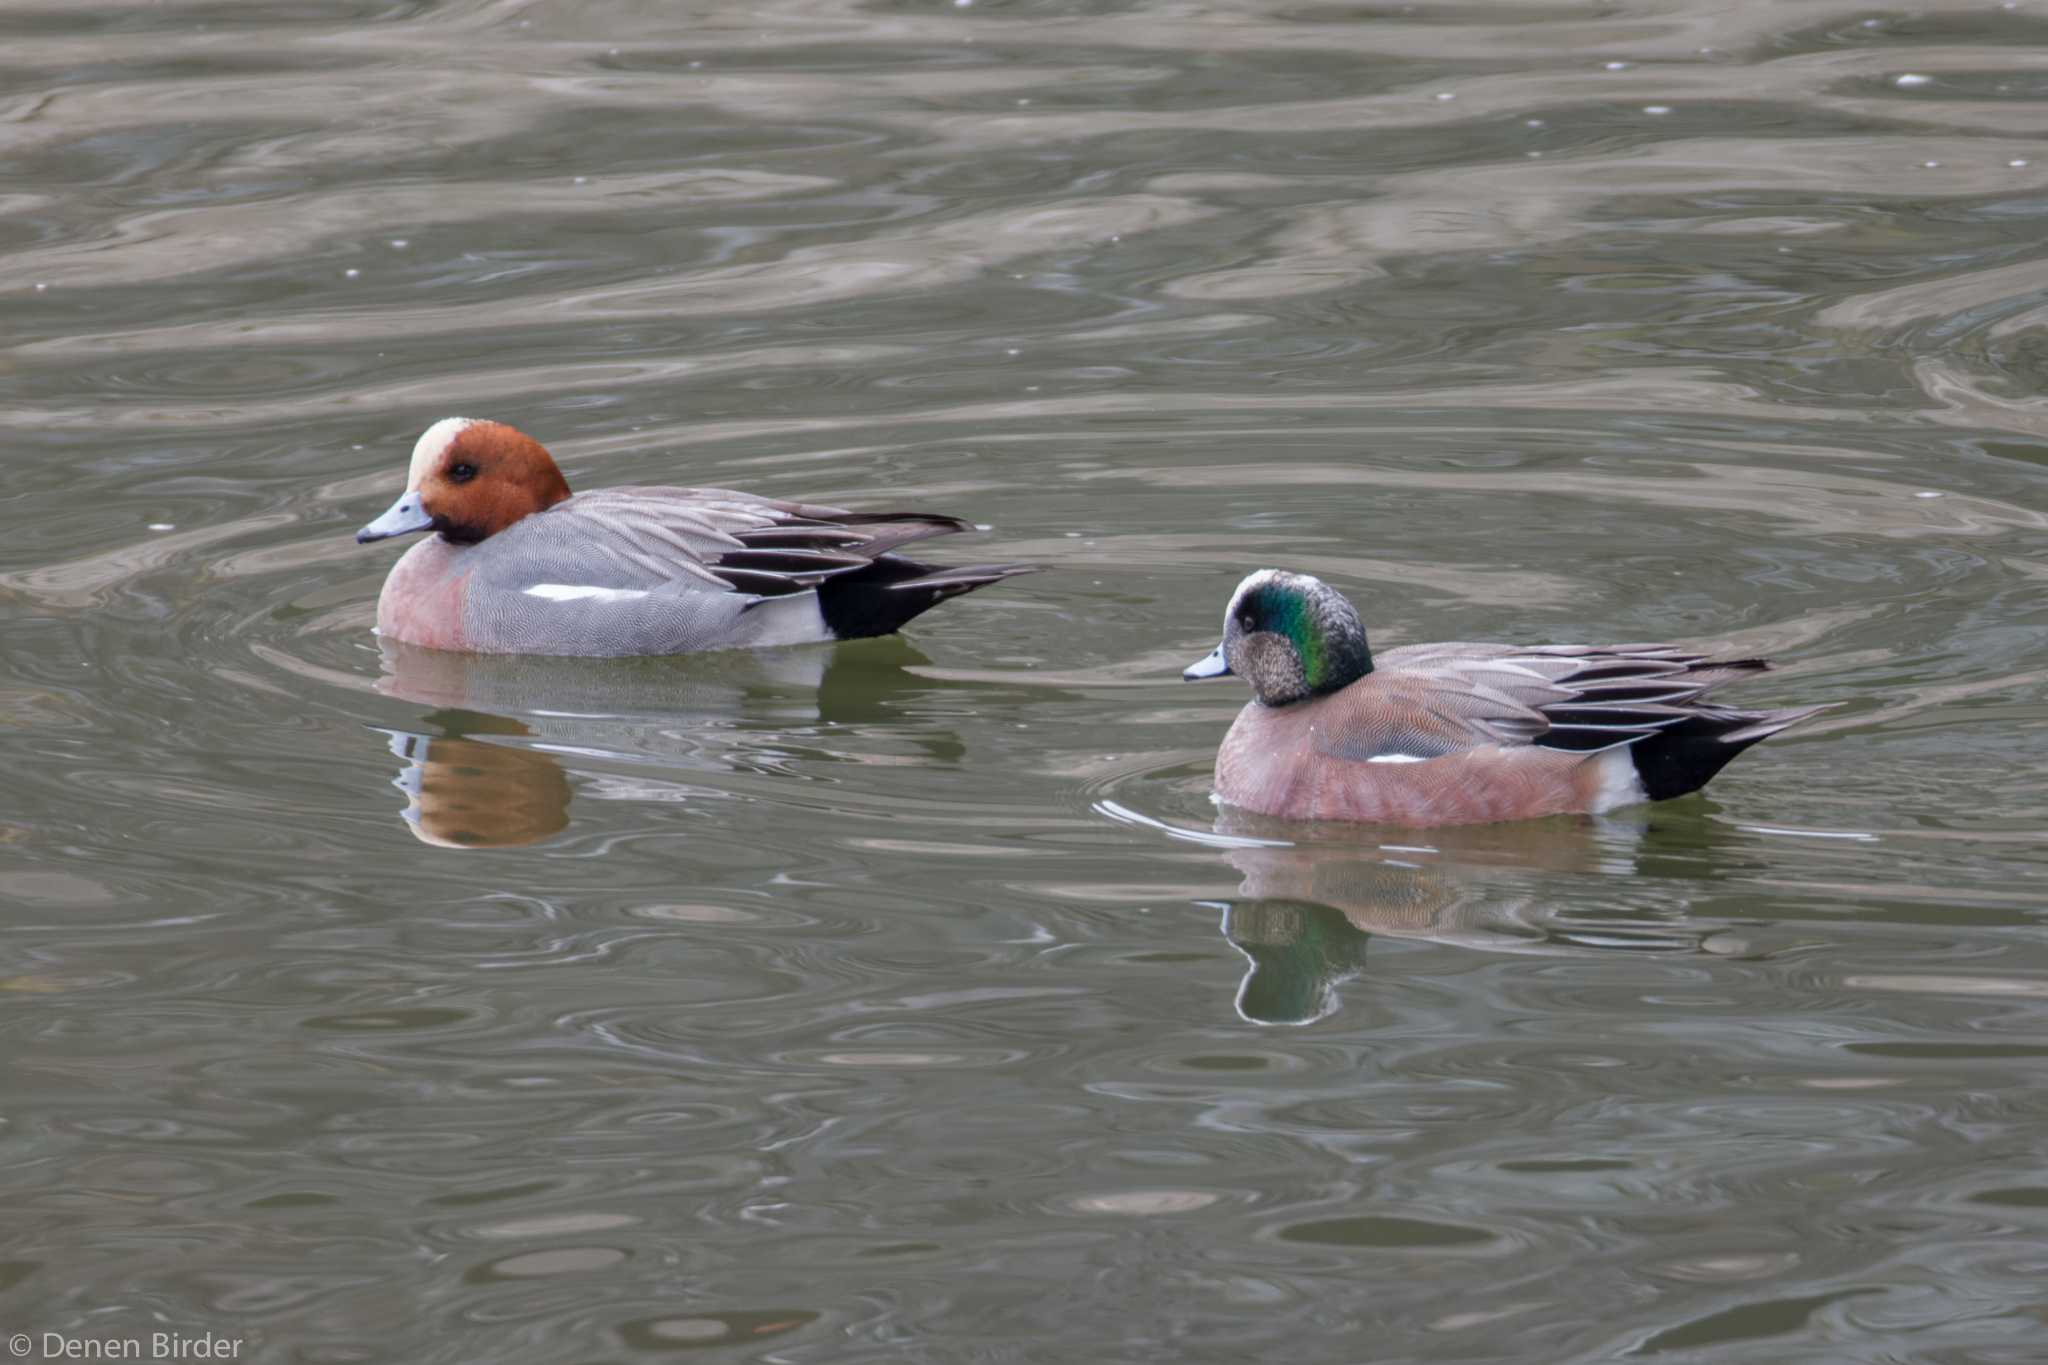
[356,417,569,544]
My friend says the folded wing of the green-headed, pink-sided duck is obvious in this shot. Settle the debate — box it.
[1317,643,1769,761]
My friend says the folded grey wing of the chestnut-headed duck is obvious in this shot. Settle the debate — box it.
[504,487,969,598]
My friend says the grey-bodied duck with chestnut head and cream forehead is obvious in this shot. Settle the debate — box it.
[356,417,1030,657]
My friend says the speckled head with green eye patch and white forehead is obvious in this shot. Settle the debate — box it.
[1182,569,1372,706]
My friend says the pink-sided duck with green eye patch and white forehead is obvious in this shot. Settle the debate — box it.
[1184,569,1827,827]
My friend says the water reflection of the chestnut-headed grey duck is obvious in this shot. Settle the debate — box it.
[377,639,965,849]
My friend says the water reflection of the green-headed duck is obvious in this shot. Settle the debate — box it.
[1212,812,1720,1023]
